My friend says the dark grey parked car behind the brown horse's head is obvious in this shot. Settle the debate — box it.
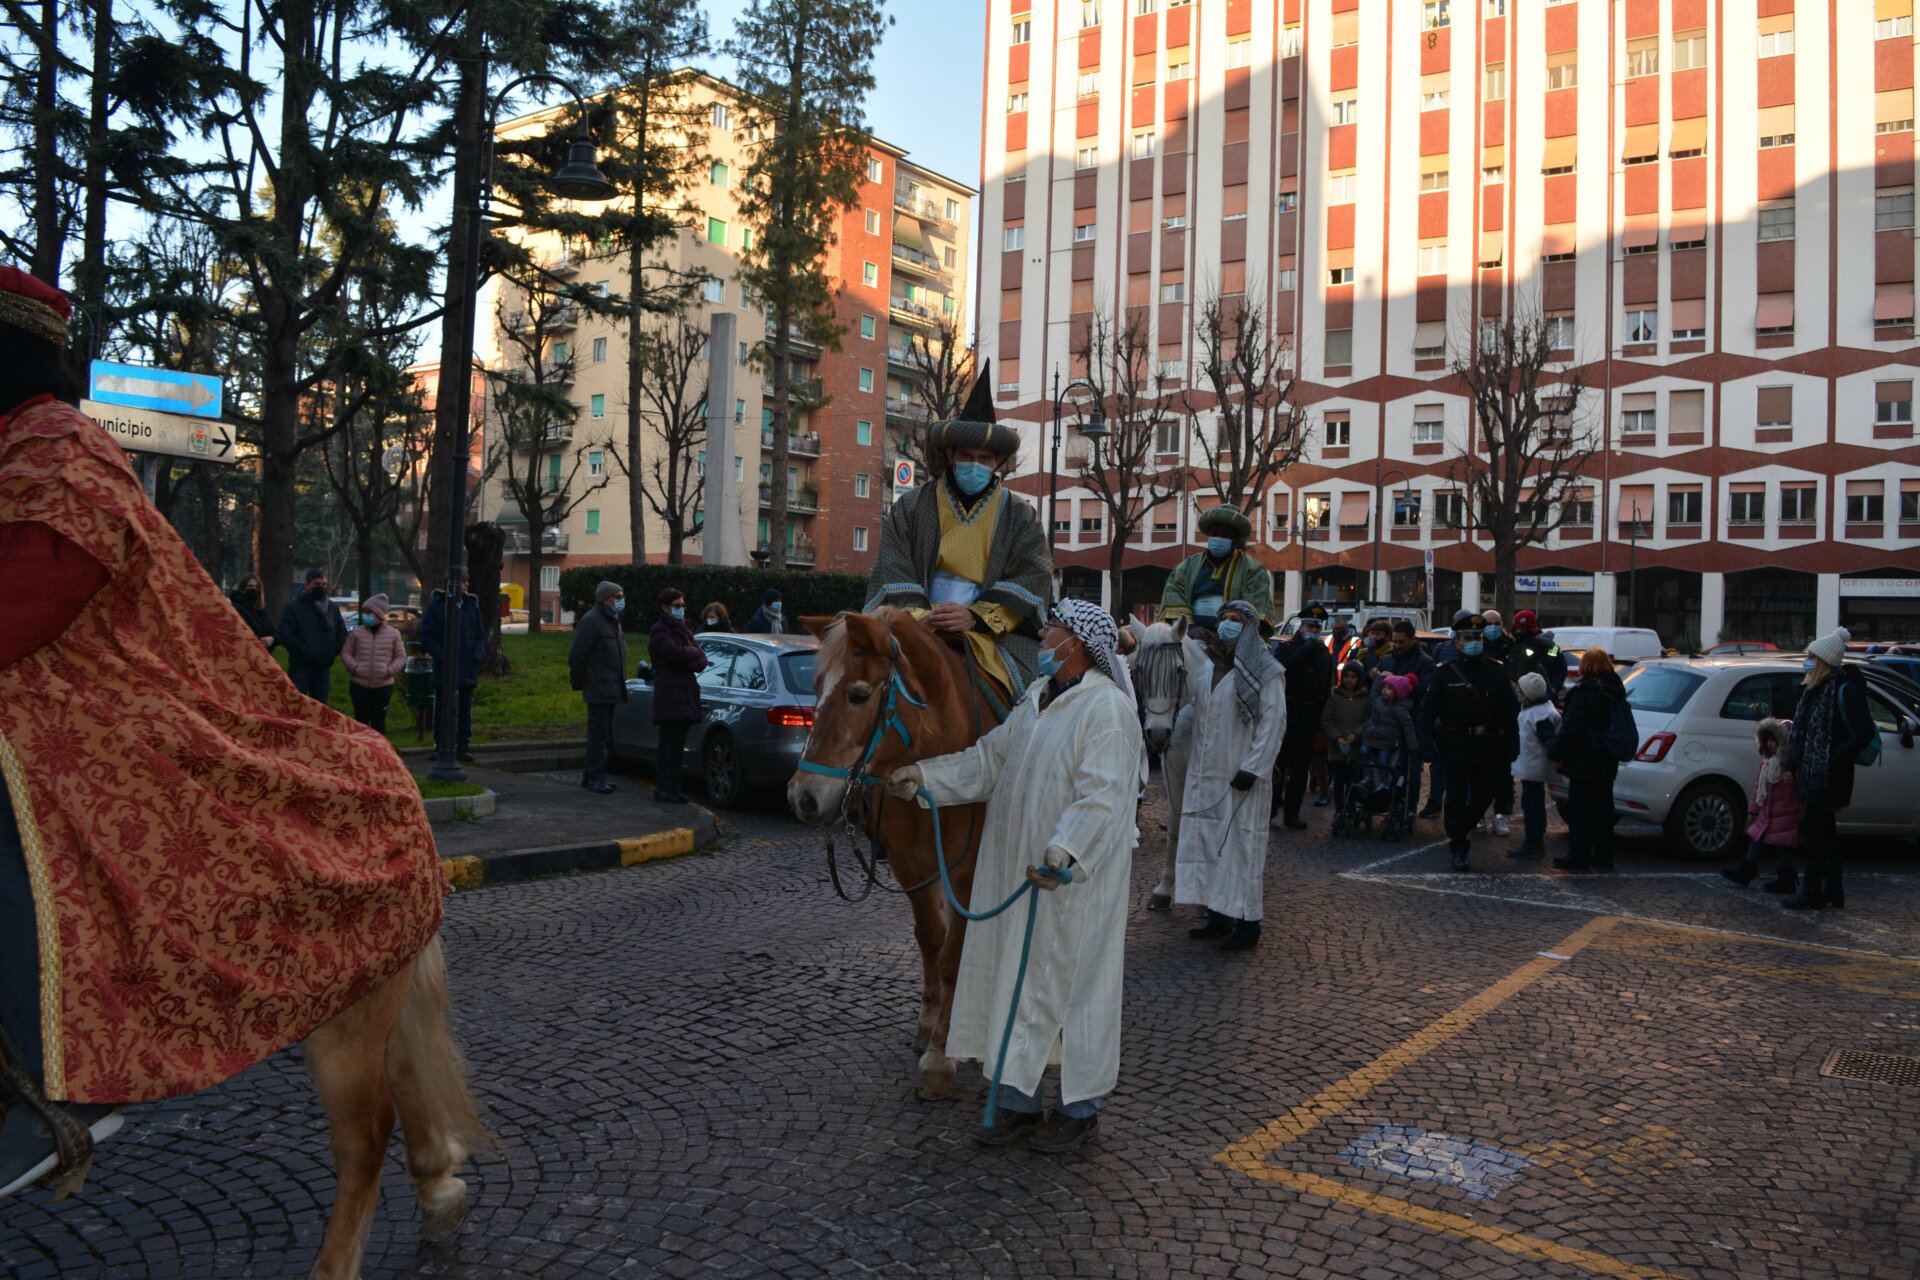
[612,631,820,810]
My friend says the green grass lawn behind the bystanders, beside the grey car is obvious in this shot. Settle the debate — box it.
[275,631,647,752]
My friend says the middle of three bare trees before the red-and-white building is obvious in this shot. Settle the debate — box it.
[1183,294,1308,528]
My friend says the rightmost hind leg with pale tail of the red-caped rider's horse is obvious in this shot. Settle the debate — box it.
[386,938,492,1244]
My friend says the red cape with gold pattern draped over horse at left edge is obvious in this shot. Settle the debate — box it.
[0,401,445,1102]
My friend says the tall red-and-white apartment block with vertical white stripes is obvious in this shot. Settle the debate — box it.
[979,0,1920,643]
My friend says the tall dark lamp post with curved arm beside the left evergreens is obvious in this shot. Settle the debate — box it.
[426,72,614,783]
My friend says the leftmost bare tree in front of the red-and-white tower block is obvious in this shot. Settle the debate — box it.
[1069,311,1181,610]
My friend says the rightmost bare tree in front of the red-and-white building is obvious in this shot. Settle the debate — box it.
[1450,315,1596,618]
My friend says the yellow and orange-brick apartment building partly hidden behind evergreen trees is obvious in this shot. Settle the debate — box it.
[476,71,977,618]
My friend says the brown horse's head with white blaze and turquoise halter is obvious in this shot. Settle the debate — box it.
[787,608,914,825]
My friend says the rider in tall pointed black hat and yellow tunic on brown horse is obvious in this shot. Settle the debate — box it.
[864,361,1052,718]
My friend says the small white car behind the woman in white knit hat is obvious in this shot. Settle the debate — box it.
[1548,654,1920,858]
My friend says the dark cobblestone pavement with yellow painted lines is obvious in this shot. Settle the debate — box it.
[0,793,1920,1280]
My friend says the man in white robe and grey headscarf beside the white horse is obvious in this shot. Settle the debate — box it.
[1173,601,1286,952]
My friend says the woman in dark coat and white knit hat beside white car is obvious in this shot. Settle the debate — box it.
[1780,628,1876,910]
